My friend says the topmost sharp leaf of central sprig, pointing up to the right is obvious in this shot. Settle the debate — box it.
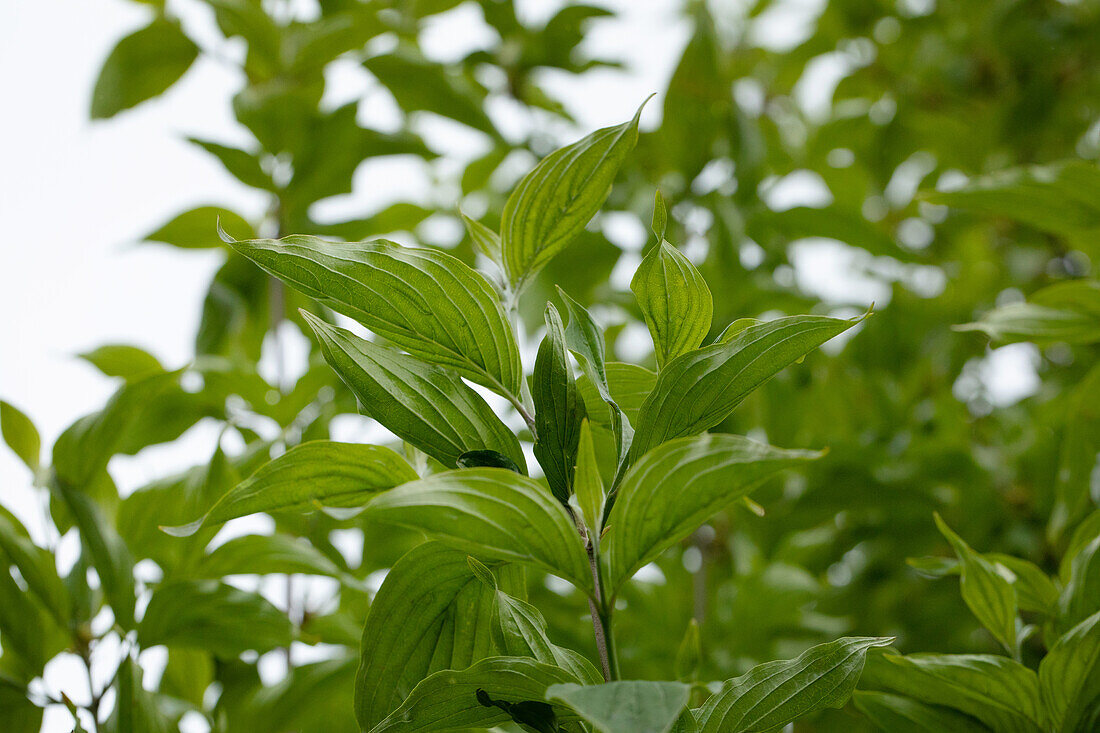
[501,107,641,292]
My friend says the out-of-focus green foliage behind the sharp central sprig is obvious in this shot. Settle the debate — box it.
[0,0,1100,733]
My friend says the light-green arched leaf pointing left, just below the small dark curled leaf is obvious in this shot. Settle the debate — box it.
[366,468,592,594]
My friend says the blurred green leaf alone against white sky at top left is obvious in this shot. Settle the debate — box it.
[91,15,199,120]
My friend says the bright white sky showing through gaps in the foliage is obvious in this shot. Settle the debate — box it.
[0,0,1035,731]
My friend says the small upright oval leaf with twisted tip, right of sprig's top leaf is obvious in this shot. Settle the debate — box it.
[630,240,714,370]
